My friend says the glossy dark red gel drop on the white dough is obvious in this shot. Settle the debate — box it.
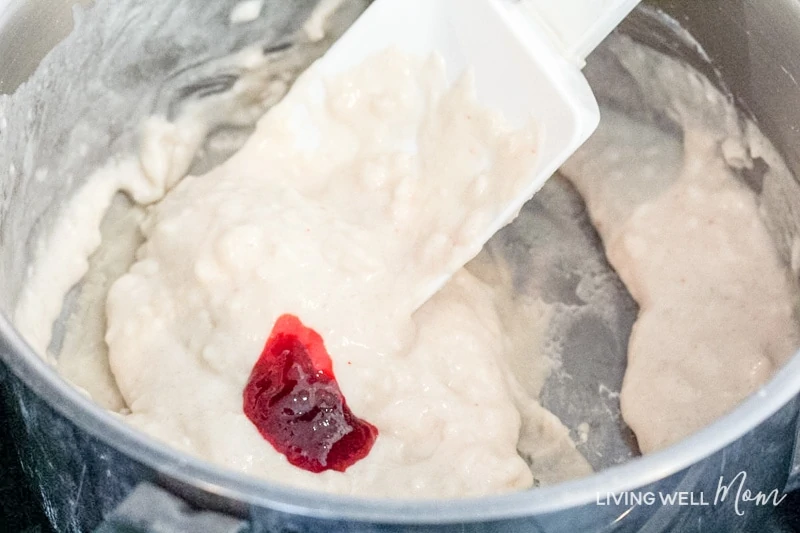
[244,315,378,472]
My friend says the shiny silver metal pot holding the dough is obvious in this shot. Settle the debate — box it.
[0,0,800,533]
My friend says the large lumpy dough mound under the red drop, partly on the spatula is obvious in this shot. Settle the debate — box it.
[106,52,536,497]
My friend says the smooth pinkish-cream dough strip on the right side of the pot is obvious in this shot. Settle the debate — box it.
[562,39,800,453]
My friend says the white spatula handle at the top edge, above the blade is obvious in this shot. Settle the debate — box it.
[514,0,639,64]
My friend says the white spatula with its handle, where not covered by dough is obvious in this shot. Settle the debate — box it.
[310,0,639,305]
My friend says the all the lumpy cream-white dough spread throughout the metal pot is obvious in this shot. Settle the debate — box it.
[15,34,800,498]
